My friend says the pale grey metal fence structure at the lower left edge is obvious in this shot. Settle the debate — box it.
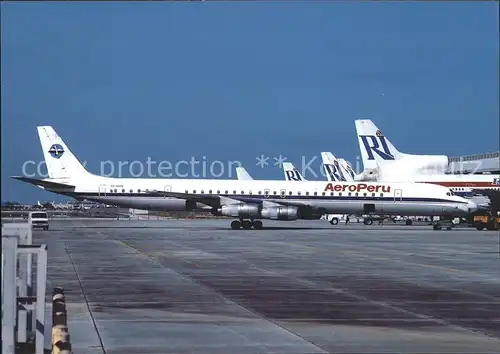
[2,223,47,354]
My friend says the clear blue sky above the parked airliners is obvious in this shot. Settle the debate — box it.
[1,2,499,202]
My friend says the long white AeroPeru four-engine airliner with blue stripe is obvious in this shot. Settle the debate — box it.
[14,126,477,229]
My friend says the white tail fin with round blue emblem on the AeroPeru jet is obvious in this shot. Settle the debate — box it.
[37,126,90,179]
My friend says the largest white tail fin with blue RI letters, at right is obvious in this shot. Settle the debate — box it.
[355,119,404,169]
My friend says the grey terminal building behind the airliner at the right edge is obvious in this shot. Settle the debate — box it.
[450,151,500,173]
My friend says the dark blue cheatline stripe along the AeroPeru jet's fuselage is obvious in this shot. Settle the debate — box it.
[67,192,467,204]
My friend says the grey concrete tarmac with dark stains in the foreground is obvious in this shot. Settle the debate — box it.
[34,220,500,354]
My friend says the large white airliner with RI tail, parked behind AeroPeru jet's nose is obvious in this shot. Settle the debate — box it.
[356,120,500,201]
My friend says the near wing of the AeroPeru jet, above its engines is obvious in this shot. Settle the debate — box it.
[150,191,318,208]
